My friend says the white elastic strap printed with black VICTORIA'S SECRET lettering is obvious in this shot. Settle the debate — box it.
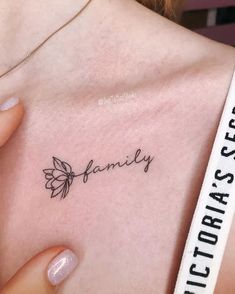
[174,72,235,294]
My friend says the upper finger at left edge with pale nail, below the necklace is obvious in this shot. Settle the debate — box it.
[0,97,24,147]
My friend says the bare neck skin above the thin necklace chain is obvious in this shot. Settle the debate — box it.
[0,0,97,74]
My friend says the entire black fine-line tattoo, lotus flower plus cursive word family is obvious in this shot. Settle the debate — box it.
[43,149,154,199]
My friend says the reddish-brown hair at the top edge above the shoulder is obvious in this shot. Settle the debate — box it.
[137,0,179,20]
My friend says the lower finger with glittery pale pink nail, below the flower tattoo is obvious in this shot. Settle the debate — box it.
[0,247,78,294]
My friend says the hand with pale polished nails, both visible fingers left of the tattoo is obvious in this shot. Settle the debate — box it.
[0,98,78,294]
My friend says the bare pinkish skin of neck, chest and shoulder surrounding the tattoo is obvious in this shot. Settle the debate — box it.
[0,0,235,294]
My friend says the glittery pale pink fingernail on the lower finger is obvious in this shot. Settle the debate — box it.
[47,249,78,286]
